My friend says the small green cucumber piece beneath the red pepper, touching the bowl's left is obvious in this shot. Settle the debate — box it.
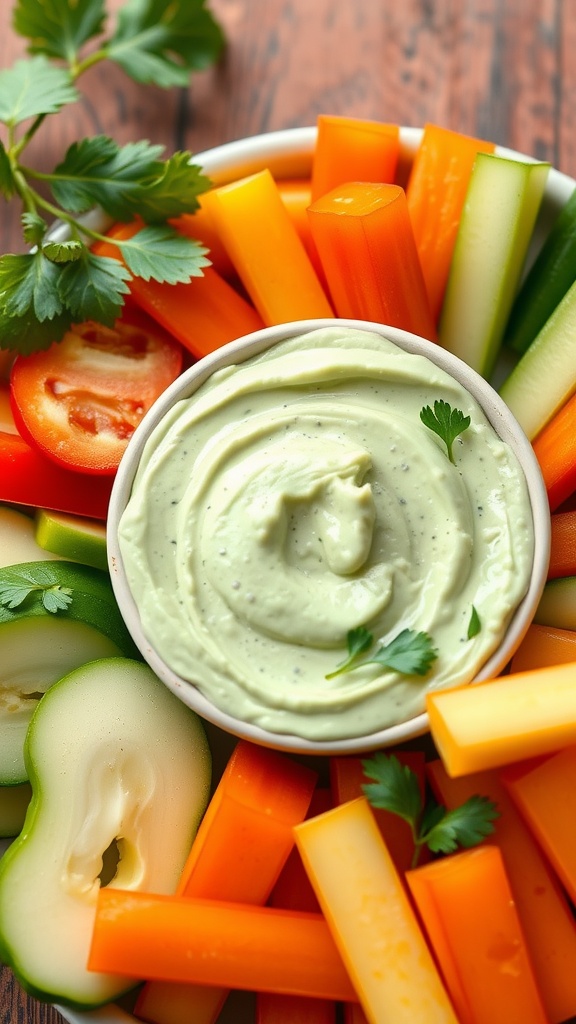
[36,509,108,570]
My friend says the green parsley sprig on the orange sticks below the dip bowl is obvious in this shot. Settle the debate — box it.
[362,753,499,866]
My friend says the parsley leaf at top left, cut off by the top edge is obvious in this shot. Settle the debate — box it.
[12,0,106,62]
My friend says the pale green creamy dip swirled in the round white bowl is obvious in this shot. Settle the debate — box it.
[119,326,534,740]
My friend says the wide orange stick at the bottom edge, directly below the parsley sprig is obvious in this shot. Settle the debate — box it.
[406,846,548,1024]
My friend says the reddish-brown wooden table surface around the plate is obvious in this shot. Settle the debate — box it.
[0,0,576,1024]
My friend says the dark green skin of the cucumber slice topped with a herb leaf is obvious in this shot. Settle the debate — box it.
[0,559,140,658]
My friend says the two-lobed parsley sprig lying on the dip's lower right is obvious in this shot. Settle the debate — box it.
[326,626,438,679]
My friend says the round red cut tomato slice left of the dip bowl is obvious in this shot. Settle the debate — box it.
[10,308,183,474]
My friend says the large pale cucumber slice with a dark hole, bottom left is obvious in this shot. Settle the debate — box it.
[0,658,211,1009]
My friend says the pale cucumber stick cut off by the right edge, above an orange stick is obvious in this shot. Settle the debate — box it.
[500,283,576,440]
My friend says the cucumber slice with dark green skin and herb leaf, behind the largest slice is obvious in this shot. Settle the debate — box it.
[0,561,139,785]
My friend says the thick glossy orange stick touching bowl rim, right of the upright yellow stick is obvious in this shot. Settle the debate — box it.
[308,181,436,340]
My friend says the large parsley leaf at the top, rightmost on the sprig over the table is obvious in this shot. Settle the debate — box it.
[106,0,224,88]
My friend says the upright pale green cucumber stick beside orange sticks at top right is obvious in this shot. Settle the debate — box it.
[439,153,549,378]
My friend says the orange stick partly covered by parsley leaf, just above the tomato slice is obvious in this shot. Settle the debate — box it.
[93,224,263,358]
